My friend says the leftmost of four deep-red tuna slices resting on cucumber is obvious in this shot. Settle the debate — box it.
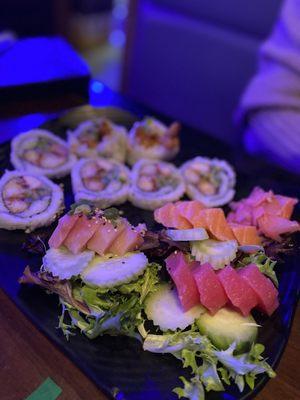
[165,251,199,311]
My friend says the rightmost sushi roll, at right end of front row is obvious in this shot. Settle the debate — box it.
[181,157,235,207]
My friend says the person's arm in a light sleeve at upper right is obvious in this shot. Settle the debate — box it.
[239,0,300,173]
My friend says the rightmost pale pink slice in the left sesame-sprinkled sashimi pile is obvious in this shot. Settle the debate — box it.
[107,221,144,256]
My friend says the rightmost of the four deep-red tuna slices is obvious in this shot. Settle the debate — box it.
[238,264,279,316]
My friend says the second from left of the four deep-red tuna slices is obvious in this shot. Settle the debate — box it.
[193,263,228,314]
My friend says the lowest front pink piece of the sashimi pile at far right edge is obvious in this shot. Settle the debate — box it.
[258,214,300,241]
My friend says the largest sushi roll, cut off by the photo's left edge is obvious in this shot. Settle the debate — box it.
[0,171,64,231]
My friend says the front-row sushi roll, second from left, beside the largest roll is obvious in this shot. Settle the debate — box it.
[71,157,129,208]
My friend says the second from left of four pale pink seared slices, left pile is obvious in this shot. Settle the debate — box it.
[63,215,100,254]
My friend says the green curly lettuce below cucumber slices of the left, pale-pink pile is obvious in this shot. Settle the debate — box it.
[59,263,161,339]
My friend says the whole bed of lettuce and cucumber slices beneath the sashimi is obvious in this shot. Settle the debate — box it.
[20,200,290,400]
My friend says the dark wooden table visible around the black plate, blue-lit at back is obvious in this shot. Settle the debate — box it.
[0,82,300,400]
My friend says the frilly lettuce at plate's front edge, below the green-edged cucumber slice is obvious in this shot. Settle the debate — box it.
[143,324,276,400]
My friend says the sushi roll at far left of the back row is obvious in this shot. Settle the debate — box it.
[10,129,76,178]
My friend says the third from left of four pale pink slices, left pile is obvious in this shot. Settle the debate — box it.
[87,218,125,256]
